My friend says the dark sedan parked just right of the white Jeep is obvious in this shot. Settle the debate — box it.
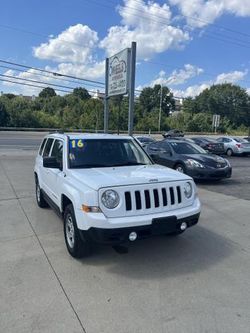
[146,139,232,179]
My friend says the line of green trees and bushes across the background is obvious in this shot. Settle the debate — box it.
[0,84,250,133]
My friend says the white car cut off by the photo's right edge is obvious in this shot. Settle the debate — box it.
[217,136,250,156]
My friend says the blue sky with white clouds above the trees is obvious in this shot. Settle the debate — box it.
[0,0,250,97]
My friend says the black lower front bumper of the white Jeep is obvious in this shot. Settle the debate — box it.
[83,213,200,245]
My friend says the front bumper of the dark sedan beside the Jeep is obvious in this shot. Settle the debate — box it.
[187,166,232,180]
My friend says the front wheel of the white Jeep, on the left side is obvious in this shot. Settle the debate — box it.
[63,204,91,258]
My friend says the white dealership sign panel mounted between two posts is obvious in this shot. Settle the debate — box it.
[108,49,130,96]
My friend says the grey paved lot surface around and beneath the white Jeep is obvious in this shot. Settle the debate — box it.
[0,133,250,333]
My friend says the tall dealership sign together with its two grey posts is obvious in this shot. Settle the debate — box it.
[104,42,136,135]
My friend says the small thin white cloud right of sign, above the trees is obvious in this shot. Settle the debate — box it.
[150,64,203,86]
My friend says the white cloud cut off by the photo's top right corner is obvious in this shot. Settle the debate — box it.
[169,0,250,28]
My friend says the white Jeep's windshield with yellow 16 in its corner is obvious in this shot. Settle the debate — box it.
[69,139,152,168]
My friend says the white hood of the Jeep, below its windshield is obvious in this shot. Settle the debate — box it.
[70,164,191,191]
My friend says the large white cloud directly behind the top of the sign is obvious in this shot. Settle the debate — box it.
[100,0,190,59]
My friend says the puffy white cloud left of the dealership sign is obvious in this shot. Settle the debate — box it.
[33,24,98,63]
